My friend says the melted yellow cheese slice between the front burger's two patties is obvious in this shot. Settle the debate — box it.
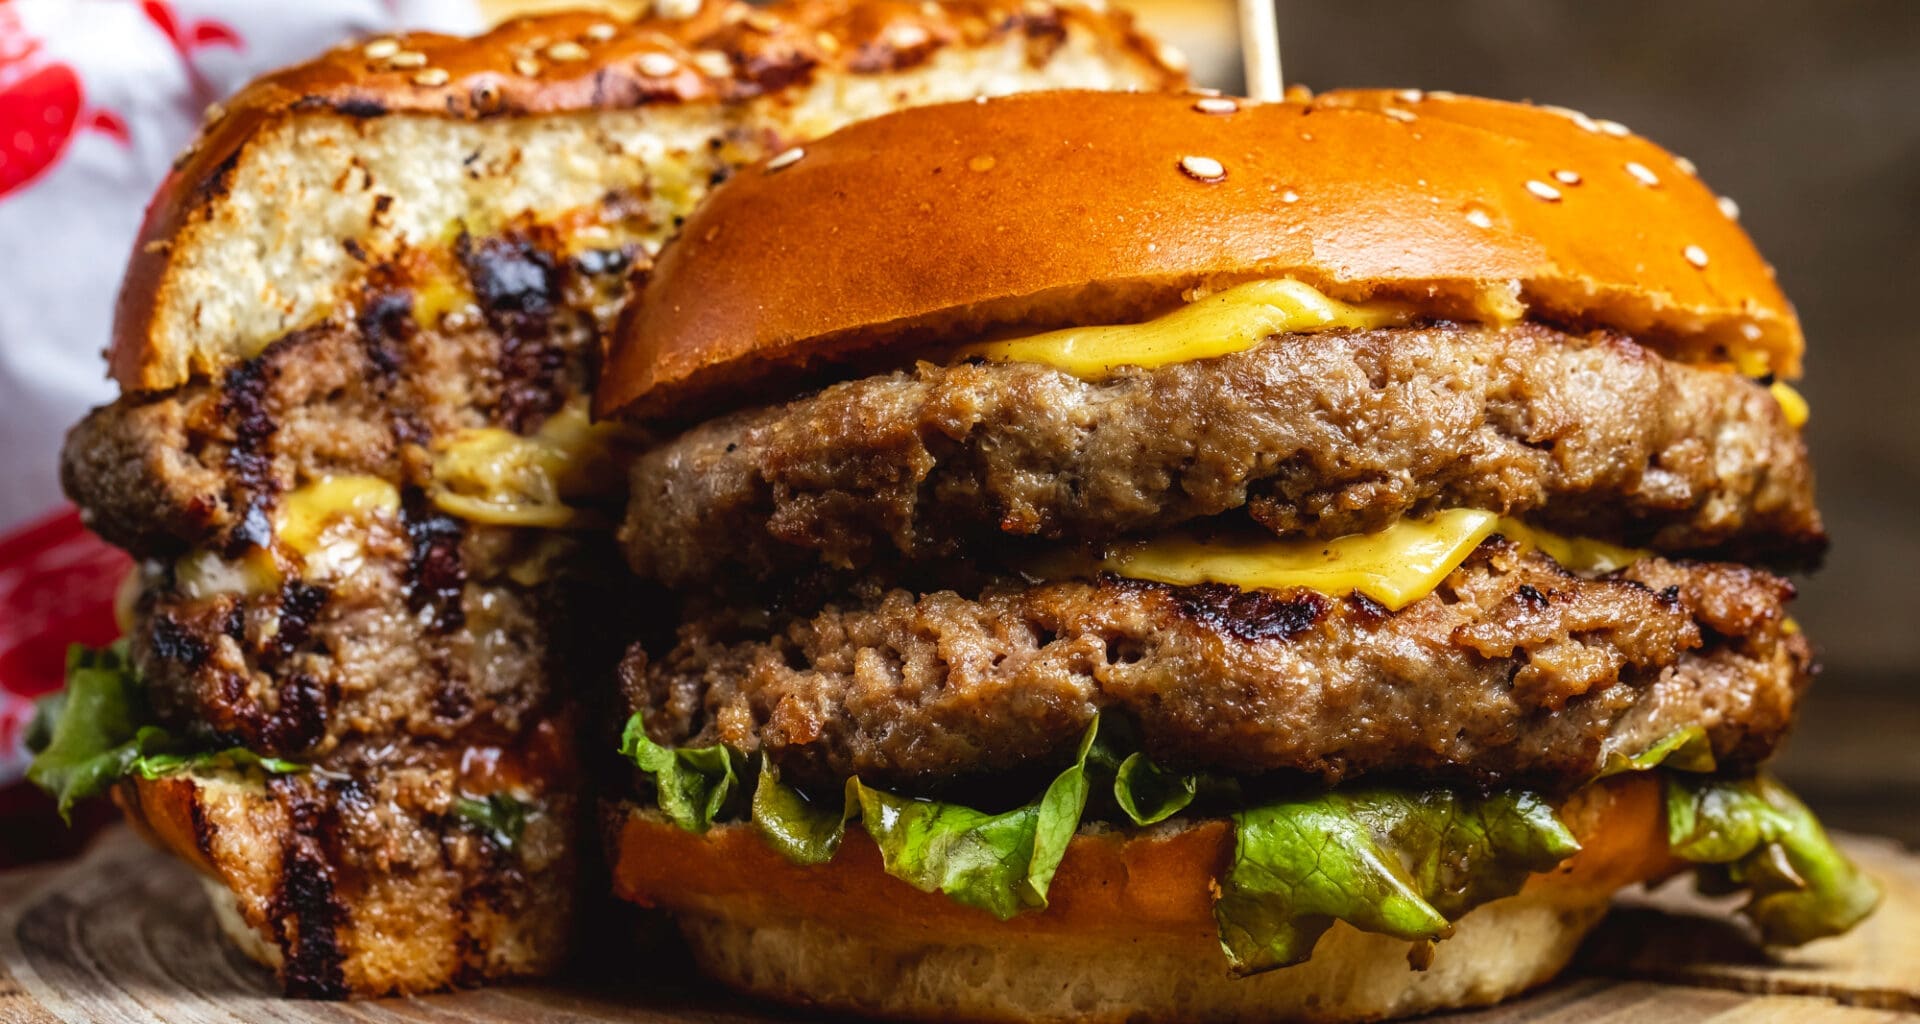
[1098,509,1645,611]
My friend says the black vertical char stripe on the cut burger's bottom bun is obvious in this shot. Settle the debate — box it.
[269,780,348,999]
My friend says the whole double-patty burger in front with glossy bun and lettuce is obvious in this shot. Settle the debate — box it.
[595,90,1878,1020]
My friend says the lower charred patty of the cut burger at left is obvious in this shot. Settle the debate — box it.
[129,507,618,759]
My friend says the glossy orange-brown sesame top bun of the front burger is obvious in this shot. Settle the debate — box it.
[597,90,1803,419]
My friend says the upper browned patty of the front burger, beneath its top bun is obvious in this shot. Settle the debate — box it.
[622,325,1824,588]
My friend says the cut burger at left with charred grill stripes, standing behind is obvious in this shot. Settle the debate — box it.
[33,0,1183,997]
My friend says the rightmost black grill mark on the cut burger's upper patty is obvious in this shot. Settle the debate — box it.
[455,232,566,434]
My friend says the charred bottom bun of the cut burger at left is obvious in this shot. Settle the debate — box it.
[113,774,574,999]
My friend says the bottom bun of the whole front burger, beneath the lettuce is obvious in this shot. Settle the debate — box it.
[614,776,1670,1020]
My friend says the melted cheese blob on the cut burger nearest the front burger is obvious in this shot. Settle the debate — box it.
[430,402,622,528]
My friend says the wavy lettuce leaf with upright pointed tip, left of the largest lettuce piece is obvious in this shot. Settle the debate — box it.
[847,720,1100,920]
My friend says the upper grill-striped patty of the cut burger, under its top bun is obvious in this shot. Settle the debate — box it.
[61,231,614,555]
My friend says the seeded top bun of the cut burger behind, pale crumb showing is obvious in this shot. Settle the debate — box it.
[109,0,1185,392]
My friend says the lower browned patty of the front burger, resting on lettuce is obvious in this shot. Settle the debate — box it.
[624,538,1811,793]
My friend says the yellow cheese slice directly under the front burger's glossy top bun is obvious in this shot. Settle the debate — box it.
[958,280,1411,380]
